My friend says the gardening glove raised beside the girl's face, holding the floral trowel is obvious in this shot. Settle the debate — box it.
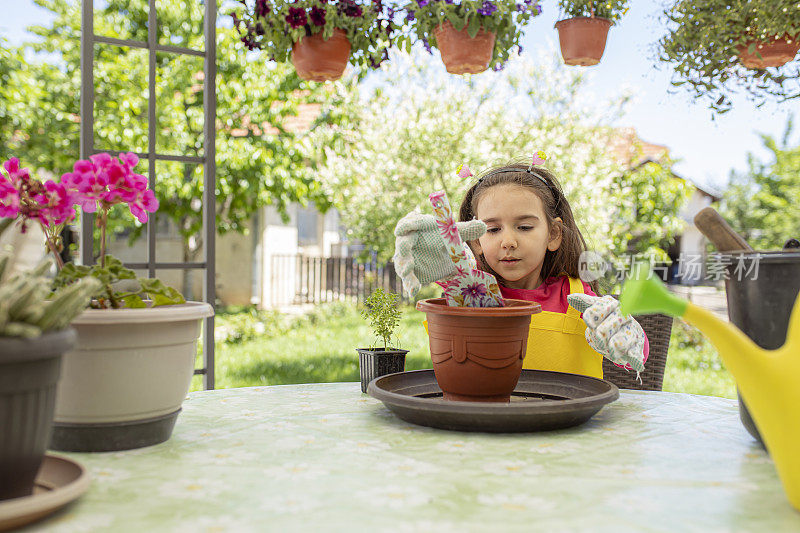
[392,212,486,298]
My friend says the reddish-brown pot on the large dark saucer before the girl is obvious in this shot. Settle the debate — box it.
[417,298,542,402]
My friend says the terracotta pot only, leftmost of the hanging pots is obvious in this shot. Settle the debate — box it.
[292,28,350,81]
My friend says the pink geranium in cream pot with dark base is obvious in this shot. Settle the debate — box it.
[0,153,214,452]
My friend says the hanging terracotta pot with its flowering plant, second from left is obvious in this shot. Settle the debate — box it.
[398,0,542,74]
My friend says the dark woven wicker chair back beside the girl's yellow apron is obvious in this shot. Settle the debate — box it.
[603,314,672,390]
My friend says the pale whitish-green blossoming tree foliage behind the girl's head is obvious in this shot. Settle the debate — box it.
[316,47,685,278]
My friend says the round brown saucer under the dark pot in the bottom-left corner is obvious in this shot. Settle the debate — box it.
[0,455,89,531]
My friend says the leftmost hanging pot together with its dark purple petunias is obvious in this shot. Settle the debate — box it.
[231,0,397,81]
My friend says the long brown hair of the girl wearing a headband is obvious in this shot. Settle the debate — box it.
[458,163,598,293]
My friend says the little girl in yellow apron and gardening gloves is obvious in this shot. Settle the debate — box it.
[394,158,649,377]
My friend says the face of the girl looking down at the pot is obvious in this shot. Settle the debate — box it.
[471,184,561,289]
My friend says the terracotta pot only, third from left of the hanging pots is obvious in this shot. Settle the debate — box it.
[555,17,611,67]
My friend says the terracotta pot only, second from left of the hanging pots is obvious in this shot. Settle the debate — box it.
[433,21,495,74]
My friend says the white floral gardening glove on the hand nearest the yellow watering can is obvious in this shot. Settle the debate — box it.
[567,294,647,373]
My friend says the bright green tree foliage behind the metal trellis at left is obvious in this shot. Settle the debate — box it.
[0,0,338,268]
